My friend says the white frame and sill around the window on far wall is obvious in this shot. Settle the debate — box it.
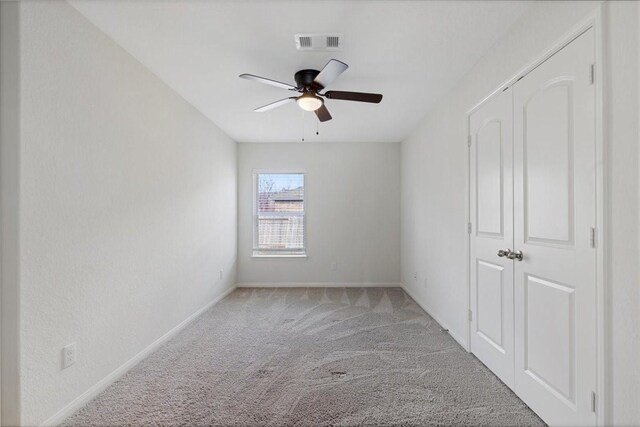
[251,169,309,259]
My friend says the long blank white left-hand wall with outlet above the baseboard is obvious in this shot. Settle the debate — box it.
[3,2,237,425]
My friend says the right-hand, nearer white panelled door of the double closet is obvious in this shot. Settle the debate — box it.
[513,29,596,425]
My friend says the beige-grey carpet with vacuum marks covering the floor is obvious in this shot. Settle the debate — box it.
[65,288,544,426]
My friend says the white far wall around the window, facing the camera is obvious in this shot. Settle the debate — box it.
[238,142,400,284]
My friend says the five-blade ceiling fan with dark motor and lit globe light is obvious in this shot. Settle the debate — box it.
[239,59,382,122]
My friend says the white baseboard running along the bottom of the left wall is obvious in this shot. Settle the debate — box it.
[41,286,235,426]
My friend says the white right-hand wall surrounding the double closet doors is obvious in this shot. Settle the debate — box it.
[401,2,640,425]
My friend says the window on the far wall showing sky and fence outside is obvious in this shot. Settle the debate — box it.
[253,173,306,257]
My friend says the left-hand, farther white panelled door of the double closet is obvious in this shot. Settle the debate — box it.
[470,89,514,387]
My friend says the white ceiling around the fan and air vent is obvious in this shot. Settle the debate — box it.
[70,0,531,142]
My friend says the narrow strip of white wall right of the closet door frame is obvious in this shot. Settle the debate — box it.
[605,2,640,425]
